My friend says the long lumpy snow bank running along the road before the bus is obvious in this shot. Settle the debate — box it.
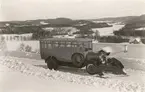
[0,56,145,92]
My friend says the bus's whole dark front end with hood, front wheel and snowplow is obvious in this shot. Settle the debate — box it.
[86,51,127,76]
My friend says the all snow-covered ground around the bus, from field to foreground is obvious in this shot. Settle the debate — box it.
[0,37,145,92]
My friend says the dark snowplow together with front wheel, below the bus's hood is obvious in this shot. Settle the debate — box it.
[86,58,127,75]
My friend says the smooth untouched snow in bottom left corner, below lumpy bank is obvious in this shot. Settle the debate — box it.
[0,64,115,92]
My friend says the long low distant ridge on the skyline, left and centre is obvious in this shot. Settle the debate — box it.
[0,18,110,28]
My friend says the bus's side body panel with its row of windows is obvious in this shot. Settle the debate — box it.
[40,40,91,62]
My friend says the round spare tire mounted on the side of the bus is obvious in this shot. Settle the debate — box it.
[72,54,85,68]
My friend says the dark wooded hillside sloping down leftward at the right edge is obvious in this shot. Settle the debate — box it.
[114,15,145,37]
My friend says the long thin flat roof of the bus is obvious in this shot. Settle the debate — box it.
[41,38,92,42]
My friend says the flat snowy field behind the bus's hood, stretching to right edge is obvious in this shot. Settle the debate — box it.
[93,43,145,59]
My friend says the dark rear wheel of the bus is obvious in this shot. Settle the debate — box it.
[46,57,58,70]
